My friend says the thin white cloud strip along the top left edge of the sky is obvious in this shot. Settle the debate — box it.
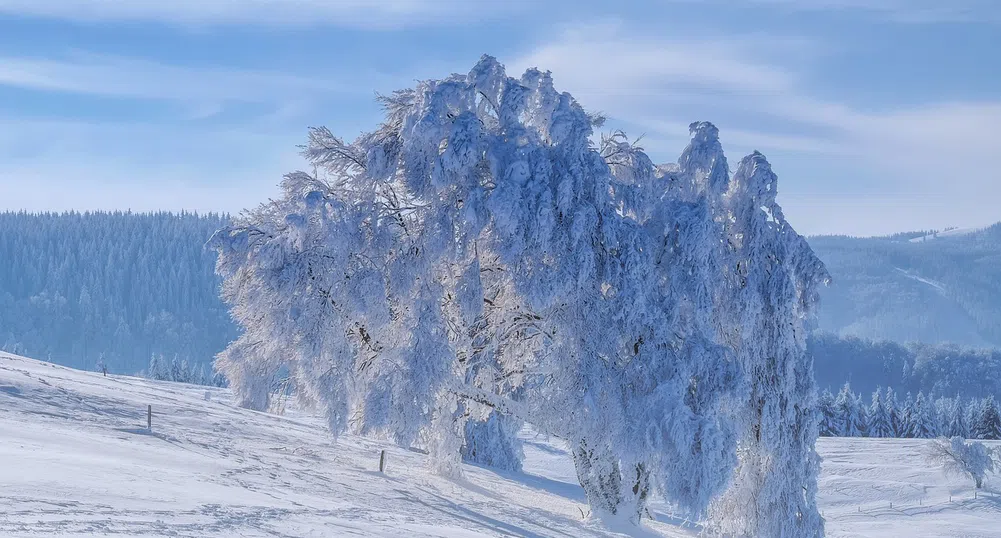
[0,0,527,28]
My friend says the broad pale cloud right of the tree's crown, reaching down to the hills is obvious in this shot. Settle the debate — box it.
[511,26,1001,233]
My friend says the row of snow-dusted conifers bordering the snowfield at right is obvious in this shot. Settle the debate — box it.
[817,383,1001,440]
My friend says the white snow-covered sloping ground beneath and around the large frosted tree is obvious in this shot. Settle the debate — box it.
[0,354,1001,538]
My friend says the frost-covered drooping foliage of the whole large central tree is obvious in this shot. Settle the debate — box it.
[212,56,825,532]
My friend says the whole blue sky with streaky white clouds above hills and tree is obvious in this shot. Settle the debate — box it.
[0,0,1001,234]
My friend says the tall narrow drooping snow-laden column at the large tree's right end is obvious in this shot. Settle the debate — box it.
[704,148,829,538]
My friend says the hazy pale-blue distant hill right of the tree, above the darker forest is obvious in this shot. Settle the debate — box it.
[809,222,1001,347]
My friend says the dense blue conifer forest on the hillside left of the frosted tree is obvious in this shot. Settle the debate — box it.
[0,211,237,375]
